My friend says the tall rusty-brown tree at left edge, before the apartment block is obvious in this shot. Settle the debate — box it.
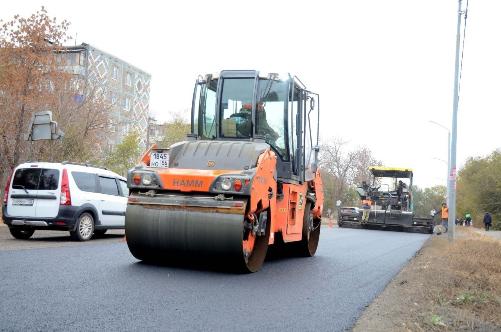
[0,7,69,168]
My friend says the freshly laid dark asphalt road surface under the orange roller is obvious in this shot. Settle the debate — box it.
[0,227,429,331]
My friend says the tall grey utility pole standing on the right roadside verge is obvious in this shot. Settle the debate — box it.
[447,0,463,242]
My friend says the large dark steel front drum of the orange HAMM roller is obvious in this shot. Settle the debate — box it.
[125,204,269,272]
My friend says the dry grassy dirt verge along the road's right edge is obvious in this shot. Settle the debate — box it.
[354,229,501,331]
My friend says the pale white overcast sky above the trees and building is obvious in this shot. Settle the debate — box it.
[0,0,501,186]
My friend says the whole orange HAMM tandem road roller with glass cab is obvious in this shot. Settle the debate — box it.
[125,71,323,272]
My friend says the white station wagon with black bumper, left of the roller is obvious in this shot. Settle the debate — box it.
[2,162,129,241]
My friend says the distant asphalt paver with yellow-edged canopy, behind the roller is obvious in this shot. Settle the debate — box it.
[338,166,433,234]
